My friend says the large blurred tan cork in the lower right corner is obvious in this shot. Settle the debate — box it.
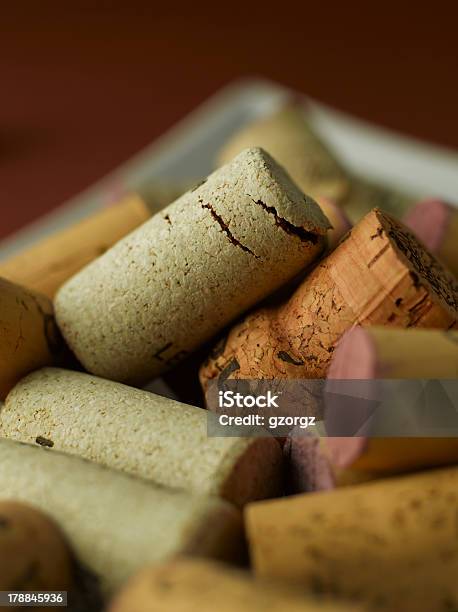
[246,468,458,612]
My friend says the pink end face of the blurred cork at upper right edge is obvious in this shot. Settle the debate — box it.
[404,200,452,253]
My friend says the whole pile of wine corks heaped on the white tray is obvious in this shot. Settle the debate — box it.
[0,105,458,612]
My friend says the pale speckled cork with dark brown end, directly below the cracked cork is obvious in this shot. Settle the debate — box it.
[0,368,282,506]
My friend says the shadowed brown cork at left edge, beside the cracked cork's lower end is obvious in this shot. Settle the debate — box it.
[0,278,66,400]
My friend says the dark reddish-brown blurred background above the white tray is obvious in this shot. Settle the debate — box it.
[0,0,458,238]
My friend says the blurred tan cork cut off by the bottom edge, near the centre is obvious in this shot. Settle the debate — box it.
[108,558,362,612]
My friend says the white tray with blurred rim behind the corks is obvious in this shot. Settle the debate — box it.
[0,80,458,259]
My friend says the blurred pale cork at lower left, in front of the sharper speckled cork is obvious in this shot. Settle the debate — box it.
[0,440,242,592]
